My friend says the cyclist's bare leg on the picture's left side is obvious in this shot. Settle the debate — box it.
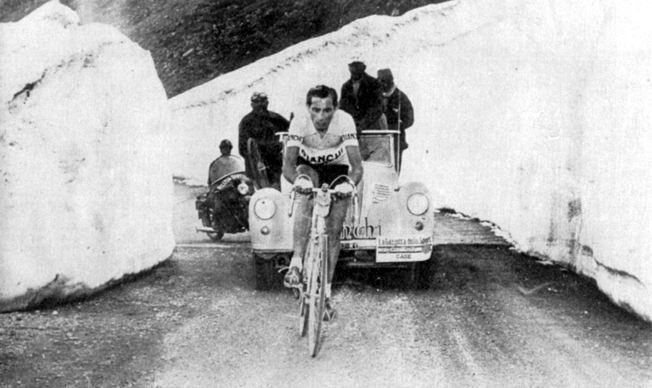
[285,164,319,286]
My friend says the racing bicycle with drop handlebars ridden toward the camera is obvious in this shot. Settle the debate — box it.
[290,175,357,357]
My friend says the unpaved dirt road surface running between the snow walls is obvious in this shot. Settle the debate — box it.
[0,185,652,388]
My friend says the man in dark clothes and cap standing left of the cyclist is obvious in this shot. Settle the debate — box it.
[238,92,290,187]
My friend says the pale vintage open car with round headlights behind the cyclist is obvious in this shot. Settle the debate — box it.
[249,130,434,290]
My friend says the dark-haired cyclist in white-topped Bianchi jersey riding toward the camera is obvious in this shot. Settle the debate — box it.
[283,85,363,320]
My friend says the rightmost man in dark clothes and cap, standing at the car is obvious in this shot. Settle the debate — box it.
[378,69,414,170]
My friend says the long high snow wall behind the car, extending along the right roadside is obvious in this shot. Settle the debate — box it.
[171,0,652,320]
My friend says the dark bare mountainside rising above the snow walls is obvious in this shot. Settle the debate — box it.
[0,0,445,97]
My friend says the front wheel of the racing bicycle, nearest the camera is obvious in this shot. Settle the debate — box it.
[308,236,328,357]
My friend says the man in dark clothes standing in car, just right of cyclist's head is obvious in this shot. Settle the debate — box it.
[340,61,382,135]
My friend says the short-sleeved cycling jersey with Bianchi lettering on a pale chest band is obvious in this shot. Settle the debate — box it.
[287,109,358,166]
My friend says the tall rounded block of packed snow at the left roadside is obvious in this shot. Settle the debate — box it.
[0,1,174,311]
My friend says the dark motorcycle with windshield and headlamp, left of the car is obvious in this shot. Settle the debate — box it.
[195,156,254,241]
